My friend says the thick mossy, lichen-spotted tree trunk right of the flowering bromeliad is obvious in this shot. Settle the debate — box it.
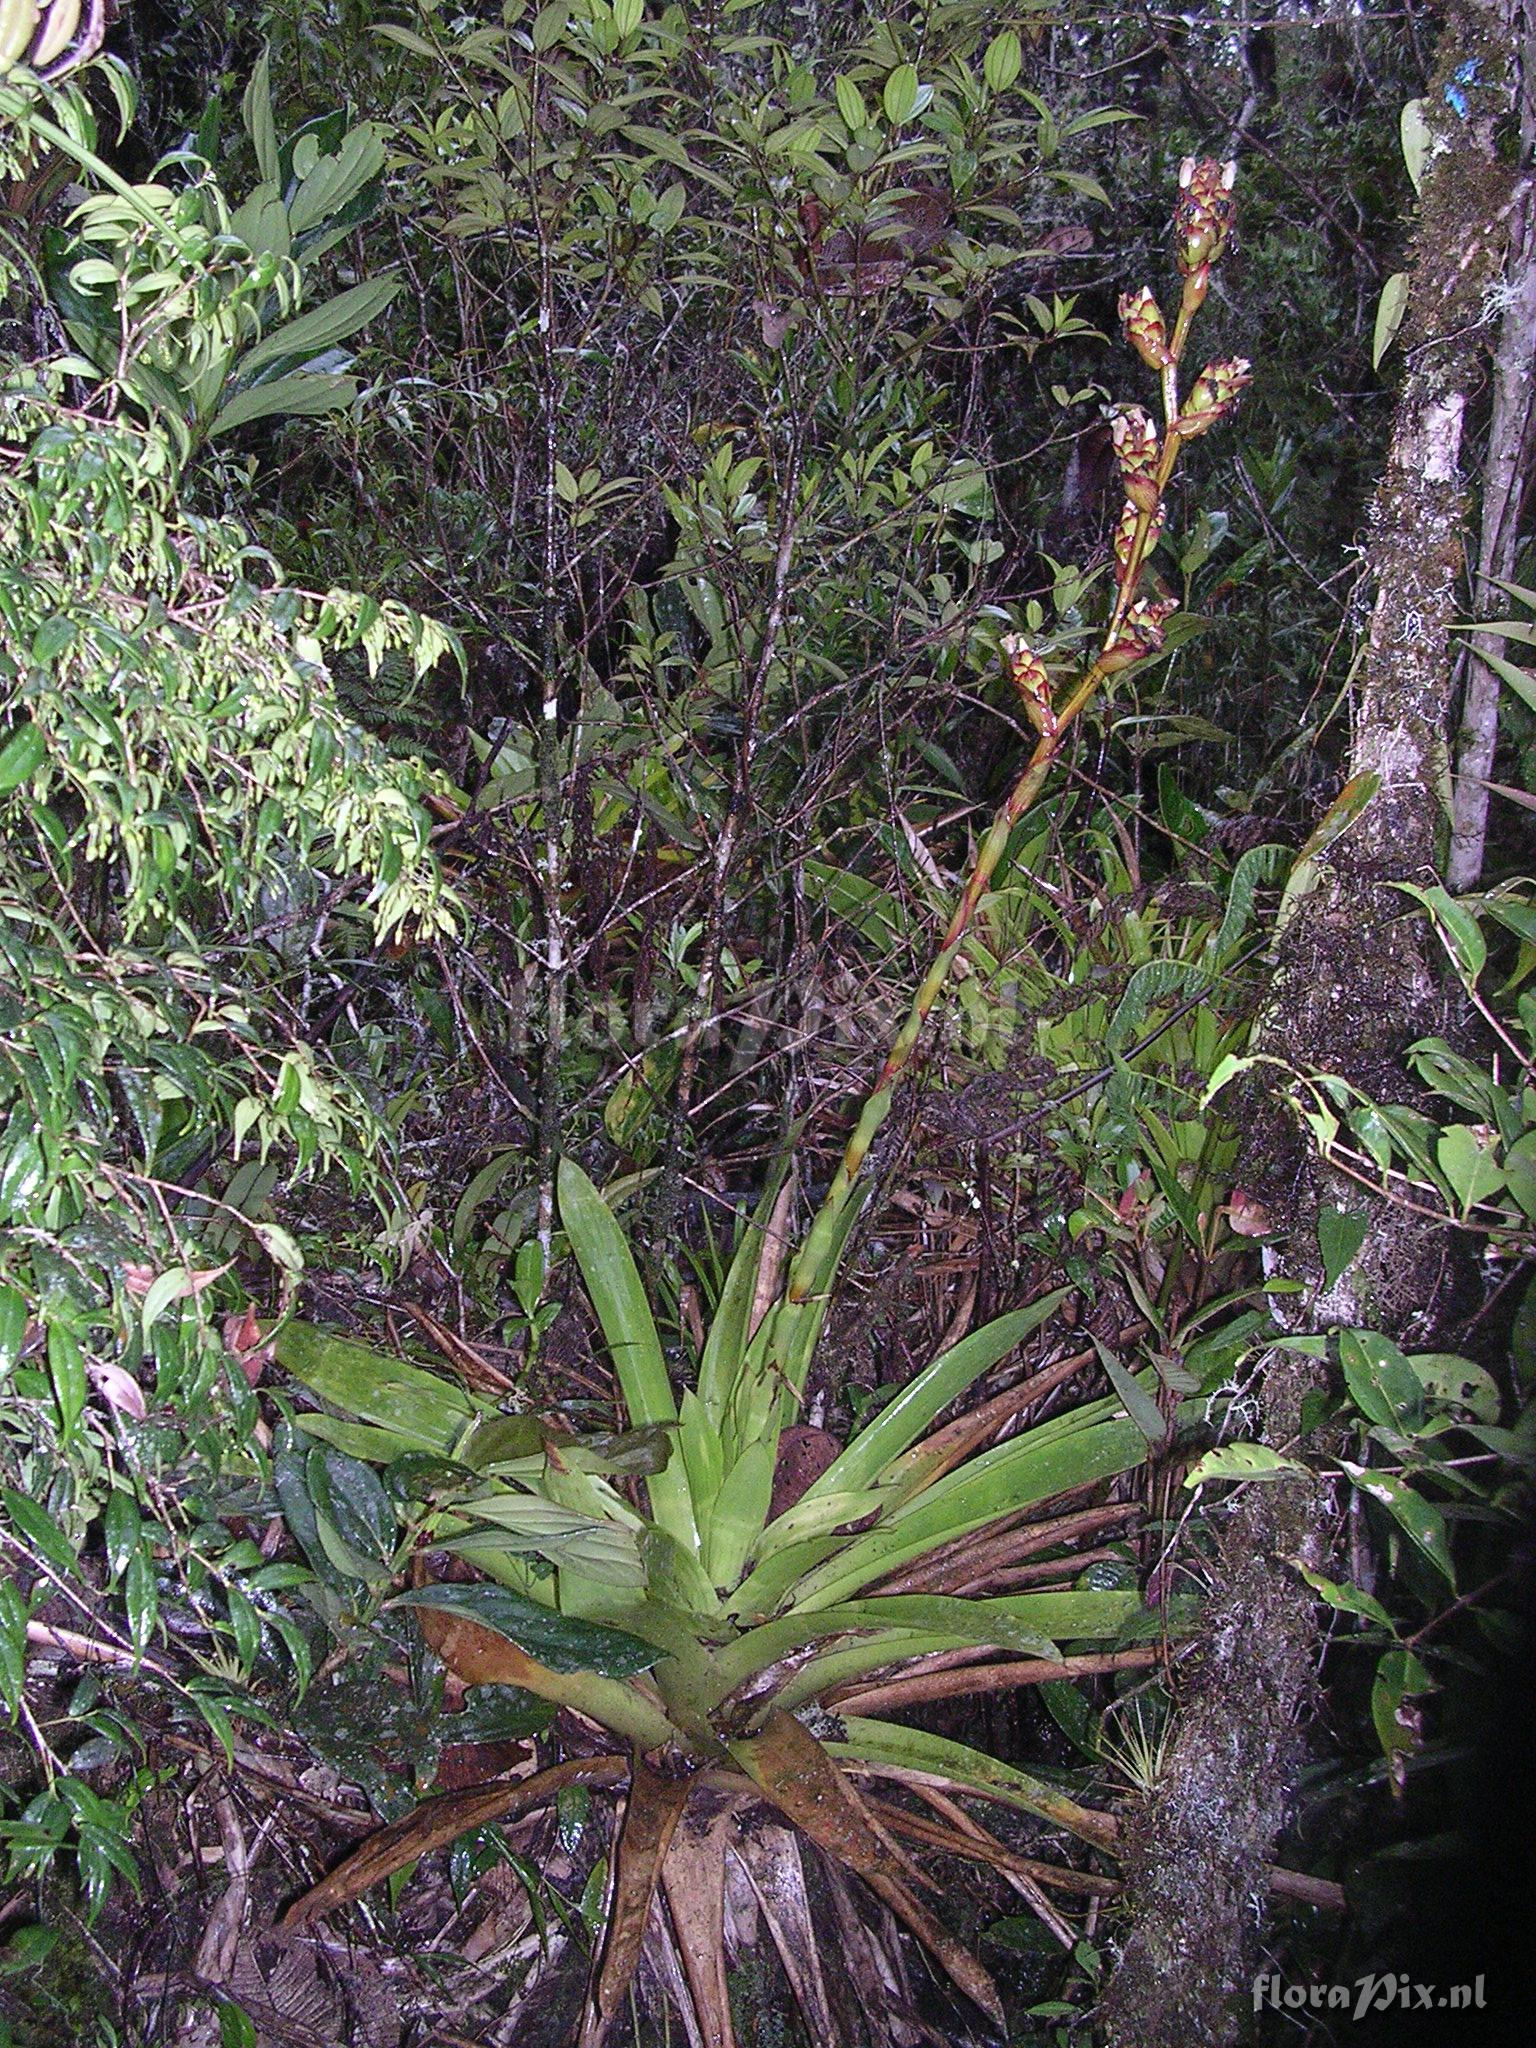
[1100,0,1518,2048]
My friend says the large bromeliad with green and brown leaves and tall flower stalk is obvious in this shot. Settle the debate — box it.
[276,162,1247,2048]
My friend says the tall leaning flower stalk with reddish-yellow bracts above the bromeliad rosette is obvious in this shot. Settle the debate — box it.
[784,158,1251,1307]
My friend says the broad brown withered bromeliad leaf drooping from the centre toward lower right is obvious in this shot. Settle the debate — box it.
[731,1714,1006,2030]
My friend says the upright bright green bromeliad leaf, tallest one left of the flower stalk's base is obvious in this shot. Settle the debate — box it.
[559,1159,698,1552]
